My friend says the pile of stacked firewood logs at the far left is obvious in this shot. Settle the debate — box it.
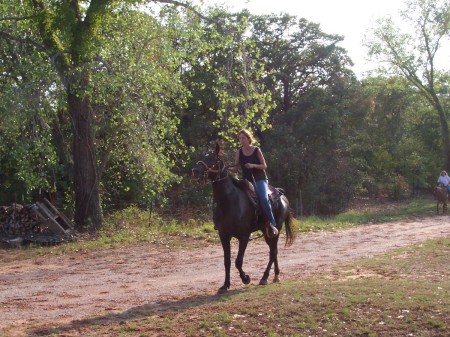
[0,204,41,236]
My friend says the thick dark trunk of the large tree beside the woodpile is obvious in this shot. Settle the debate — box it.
[68,86,102,231]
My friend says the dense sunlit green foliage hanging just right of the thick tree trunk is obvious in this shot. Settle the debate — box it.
[89,10,192,206]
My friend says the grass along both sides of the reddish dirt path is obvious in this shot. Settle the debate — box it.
[0,199,450,337]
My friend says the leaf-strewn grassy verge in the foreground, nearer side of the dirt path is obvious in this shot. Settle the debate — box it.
[31,238,450,337]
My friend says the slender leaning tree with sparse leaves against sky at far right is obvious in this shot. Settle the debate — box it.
[366,0,450,169]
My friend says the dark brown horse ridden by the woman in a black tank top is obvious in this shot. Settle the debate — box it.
[192,145,295,293]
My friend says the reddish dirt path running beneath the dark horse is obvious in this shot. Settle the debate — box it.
[0,216,450,332]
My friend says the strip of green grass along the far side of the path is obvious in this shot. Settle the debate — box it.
[100,198,435,238]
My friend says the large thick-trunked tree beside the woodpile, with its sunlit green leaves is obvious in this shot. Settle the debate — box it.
[0,0,278,230]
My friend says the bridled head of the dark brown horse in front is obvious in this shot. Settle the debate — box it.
[192,144,225,182]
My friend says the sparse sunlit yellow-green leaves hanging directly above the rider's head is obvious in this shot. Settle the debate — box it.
[176,8,273,147]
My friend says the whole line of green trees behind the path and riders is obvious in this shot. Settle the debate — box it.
[0,0,450,230]
